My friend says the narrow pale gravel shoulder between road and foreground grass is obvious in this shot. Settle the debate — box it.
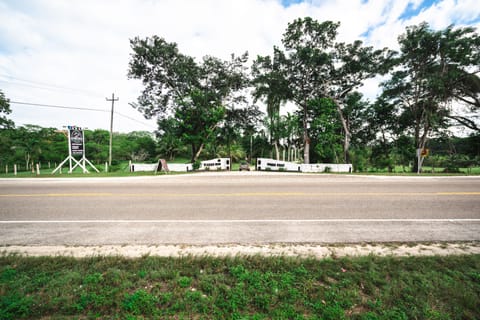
[0,241,480,259]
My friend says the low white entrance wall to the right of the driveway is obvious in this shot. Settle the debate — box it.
[255,158,352,172]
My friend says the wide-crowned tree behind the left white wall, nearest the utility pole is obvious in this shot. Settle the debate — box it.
[128,36,248,161]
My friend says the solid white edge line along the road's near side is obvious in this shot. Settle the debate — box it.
[0,219,480,224]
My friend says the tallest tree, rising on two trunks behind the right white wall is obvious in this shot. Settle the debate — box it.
[282,17,391,163]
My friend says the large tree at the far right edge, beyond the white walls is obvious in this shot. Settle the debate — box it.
[382,23,480,171]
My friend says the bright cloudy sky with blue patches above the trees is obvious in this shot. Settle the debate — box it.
[0,0,480,132]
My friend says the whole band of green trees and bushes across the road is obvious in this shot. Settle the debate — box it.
[0,17,480,173]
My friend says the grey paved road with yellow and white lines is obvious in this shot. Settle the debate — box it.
[0,172,480,245]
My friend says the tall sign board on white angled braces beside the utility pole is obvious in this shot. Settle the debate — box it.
[52,126,99,174]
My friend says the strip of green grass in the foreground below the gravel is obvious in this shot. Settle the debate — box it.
[0,255,480,319]
